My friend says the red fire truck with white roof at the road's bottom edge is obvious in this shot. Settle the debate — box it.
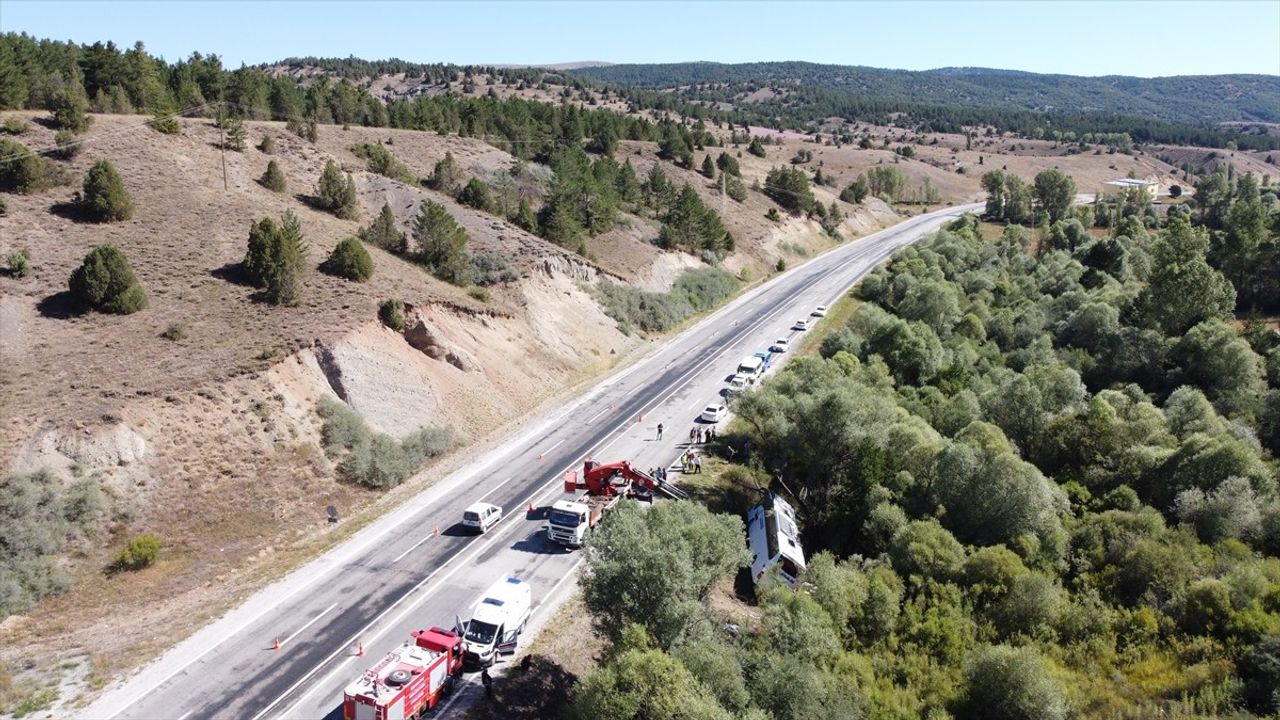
[342,628,462,720]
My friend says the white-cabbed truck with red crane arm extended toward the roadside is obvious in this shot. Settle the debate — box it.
[547,460,689,547]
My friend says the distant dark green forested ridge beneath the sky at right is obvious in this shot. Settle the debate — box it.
[568,63,1280,124]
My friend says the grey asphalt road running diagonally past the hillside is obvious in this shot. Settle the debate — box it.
[81,206,978,720]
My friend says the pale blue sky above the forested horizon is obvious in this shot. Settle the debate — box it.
[0,0,1280,77]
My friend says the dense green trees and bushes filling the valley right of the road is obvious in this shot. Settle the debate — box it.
[558,174,1280,720]
